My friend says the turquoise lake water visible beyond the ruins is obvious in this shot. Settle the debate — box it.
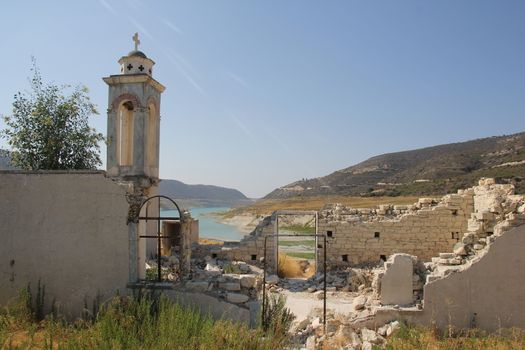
[162,207,245,241]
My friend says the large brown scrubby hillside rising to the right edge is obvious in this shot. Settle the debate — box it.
[265,132,525,199]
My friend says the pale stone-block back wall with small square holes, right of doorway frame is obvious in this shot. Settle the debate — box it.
[319,191,473,264]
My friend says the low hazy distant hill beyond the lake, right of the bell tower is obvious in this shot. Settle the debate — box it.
[159,180,252,208]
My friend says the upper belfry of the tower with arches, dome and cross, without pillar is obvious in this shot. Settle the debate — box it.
[103,33,165,188]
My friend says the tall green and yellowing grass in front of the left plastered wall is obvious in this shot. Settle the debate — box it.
[0,297,289,350]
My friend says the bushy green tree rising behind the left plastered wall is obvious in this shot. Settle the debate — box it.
[0,59,104,170]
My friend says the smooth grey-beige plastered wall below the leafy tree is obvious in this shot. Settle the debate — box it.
[0,172,129,318]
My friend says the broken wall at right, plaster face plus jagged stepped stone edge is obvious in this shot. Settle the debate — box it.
[368,179,525,331]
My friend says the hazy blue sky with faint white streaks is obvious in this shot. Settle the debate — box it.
[0,0,525,197]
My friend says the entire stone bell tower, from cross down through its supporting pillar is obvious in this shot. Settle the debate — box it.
[103,33,165,283]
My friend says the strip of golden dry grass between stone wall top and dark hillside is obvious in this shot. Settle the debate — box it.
[224,196,419,217]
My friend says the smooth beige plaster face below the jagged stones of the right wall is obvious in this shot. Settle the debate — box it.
[370,225,525,331]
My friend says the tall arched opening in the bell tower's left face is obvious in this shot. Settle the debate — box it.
[117,101,134,166]
